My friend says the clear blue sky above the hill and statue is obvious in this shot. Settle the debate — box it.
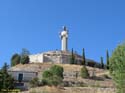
[0,0,125,67]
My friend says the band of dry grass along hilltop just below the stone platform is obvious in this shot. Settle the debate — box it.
[11,62,105,72]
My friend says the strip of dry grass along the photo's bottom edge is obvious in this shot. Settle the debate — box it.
[22,86,115,93]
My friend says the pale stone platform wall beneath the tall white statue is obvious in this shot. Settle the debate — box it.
[29,51,82,64]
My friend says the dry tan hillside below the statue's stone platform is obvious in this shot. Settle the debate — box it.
[9,63,115,93]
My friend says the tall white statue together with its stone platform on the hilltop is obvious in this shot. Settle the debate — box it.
[29,26,94,64]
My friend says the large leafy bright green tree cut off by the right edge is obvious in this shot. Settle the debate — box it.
[109,44,125,93]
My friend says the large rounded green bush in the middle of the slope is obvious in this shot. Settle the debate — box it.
[42,65,63,86]
